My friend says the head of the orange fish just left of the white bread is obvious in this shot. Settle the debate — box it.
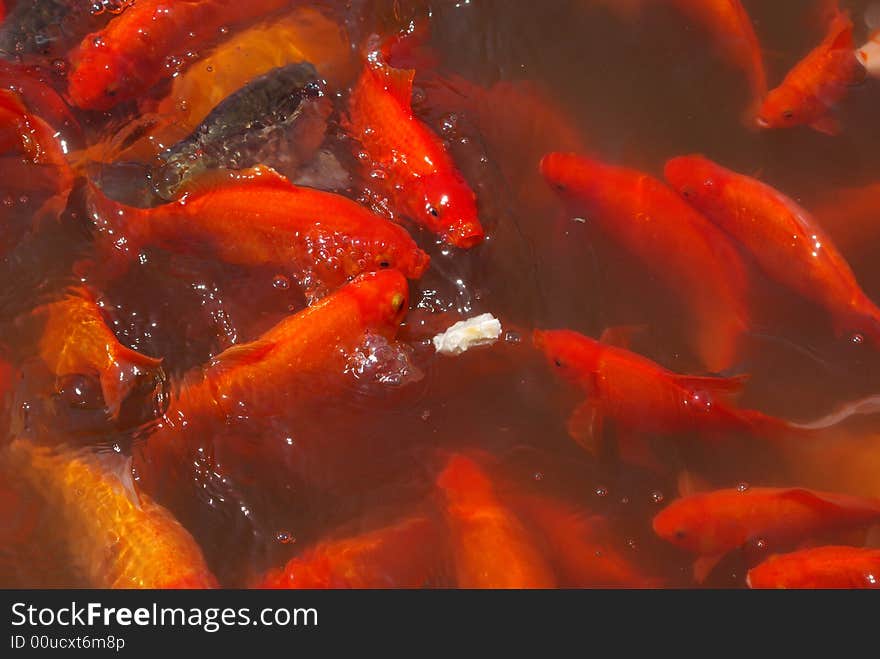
[339,269,409,338]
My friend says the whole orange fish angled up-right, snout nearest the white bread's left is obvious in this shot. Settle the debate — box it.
[136,270,409,490]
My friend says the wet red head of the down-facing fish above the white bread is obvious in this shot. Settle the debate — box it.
[412,171,486,249]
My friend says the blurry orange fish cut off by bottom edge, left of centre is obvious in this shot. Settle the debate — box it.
[255,516,443,589]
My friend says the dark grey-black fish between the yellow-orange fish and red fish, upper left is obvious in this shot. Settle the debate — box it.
[153,62,332,200]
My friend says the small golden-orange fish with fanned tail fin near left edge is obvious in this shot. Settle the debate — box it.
[26,288,162,418]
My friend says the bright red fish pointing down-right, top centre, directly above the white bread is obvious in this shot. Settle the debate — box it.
[347,39,485,248]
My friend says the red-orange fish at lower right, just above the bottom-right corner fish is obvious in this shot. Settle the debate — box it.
[653,487,880,582]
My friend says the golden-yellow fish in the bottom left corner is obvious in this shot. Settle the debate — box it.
[8,439,217,588]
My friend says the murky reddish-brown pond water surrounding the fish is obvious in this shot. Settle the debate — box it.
[0,0,880,587]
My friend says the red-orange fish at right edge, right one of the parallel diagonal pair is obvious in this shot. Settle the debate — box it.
[665,156,880,345]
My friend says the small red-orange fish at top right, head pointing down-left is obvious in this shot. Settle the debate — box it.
[756,12,865,135]
